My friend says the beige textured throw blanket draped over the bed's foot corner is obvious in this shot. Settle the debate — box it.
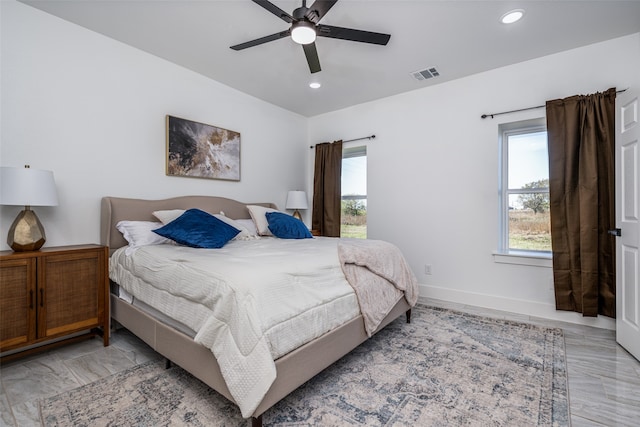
[338,239,418,336]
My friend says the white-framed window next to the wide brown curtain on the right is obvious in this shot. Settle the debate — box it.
[499,119,551,255]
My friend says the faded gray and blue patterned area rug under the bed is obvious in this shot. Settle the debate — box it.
[40,305,569,426]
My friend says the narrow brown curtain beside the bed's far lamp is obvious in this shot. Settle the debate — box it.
[311,141,342,237]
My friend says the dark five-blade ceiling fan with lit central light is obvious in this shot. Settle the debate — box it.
[231,0,391,73]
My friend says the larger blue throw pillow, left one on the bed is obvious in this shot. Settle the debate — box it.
[153,209,240,249]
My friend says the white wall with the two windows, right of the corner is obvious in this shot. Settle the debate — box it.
[309,34,640,328]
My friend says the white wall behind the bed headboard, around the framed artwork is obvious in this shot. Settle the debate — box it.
[0,1,309,249]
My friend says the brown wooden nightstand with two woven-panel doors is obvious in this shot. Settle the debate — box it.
[0,245,109,361]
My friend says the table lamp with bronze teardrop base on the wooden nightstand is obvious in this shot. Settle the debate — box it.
[0,165,58,252]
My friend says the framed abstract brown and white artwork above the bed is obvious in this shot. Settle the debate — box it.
[166,115,240,181]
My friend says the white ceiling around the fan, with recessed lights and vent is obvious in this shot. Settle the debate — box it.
[22,0,640,116]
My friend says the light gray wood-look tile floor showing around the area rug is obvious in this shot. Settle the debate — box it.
[0,300,640,427]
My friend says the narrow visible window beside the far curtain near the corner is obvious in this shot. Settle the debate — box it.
[340,146,367,239]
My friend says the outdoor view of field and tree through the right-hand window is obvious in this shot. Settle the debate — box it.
[506,129,551,251]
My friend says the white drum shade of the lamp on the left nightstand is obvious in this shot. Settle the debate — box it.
[0,166,58,206]
